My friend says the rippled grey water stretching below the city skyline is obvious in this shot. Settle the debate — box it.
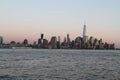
[0,49,120,80]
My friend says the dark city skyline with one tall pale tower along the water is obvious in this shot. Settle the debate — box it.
[0,24,117,50]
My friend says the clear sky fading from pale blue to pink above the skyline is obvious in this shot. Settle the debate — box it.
[0,0,120,47]
